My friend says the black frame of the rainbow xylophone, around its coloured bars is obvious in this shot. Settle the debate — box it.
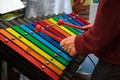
[0,13,87,80]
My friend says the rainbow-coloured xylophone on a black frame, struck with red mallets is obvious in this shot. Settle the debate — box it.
[0,13,89,80]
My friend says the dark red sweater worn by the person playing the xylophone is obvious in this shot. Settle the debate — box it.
[75,0,120,65]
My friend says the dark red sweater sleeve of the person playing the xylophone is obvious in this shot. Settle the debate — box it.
[75,0,120,54]
